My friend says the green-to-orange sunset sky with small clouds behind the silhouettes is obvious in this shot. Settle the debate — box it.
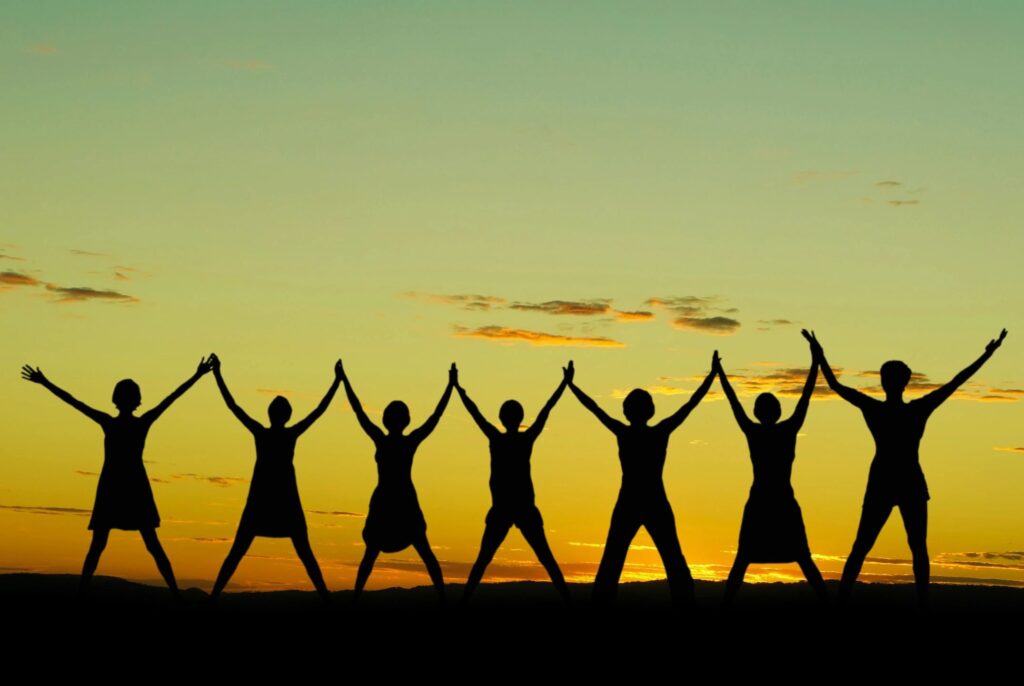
[0,1,1024,590]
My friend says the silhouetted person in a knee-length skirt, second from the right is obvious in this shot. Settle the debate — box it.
[716,341,827,606]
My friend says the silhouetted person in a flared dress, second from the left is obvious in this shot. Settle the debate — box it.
[210,355,342,600]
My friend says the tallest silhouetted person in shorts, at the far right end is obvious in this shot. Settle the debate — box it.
[803,329,1007,607]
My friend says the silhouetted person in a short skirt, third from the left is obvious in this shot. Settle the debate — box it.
[339,362,458,603]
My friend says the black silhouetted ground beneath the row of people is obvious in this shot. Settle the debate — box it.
[6,574,1024,681]
